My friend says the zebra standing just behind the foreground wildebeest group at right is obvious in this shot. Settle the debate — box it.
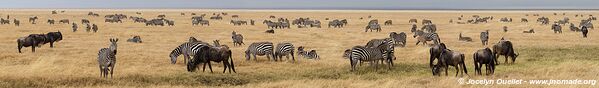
[414,30,441,45]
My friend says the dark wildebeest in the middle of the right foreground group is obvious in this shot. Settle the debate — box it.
[472,48,497,75]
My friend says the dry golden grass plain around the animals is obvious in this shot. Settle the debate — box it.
[0,9,599,88]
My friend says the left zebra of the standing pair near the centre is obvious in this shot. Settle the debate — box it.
[245,42,277,61]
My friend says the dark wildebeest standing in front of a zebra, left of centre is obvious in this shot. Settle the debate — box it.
[187,45,237,73]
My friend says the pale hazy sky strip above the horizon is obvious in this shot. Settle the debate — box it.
[0,0,599,9]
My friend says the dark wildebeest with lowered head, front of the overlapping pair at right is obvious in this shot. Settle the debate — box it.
[439,49,468,77]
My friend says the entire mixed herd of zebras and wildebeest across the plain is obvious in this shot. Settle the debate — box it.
[12,11,596,77]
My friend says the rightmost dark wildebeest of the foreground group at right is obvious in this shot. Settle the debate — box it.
[493,40,519,65]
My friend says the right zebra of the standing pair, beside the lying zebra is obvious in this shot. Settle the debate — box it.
[275,43,295,61]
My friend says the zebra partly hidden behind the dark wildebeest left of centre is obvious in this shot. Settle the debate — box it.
[169,41,211,64]
